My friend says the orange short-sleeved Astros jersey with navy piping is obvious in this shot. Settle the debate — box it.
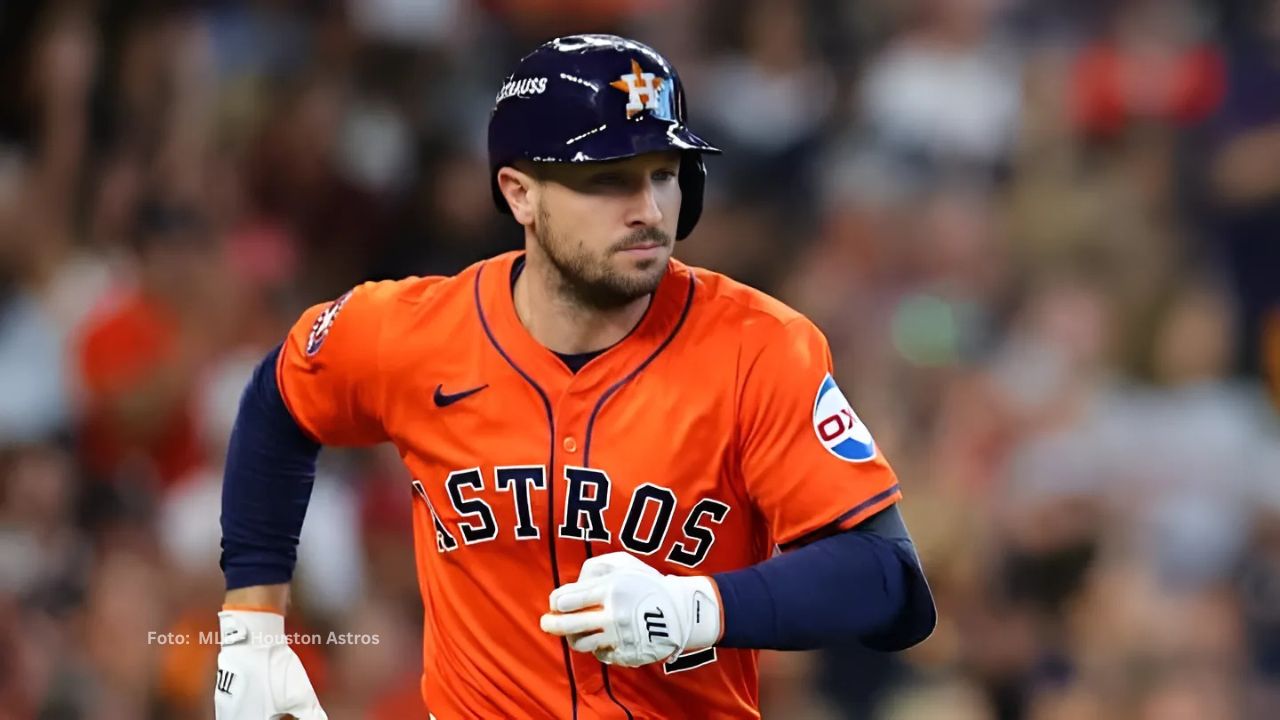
[278,252,900,720]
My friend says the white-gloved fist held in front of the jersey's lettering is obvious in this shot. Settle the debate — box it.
[541,552,721,667]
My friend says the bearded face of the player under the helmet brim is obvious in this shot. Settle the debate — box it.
[534,151,680,309]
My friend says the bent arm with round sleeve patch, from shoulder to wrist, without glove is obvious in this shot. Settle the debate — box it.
[714,318,936,650]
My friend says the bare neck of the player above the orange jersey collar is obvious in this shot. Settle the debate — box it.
[512,253,653,355]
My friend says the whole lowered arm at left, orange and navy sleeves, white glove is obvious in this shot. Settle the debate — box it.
[214,284,384,720]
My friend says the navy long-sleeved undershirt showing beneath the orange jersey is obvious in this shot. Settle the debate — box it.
[221,263,937,651]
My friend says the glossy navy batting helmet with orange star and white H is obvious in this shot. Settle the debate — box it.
[489,35,719,240]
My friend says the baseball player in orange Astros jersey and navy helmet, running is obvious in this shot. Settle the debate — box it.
[214,35,934,720]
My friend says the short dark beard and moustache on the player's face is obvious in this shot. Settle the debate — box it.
[534,208,671,310]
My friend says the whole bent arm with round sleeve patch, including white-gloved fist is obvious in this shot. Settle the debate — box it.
[543,319,936,665]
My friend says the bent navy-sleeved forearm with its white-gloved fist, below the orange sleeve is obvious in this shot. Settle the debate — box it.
[541,505,937,666]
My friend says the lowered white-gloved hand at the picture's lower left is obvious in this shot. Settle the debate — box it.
[214,610,329,720]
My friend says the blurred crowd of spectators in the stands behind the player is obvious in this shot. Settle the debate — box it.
[0,0,1280,720]
